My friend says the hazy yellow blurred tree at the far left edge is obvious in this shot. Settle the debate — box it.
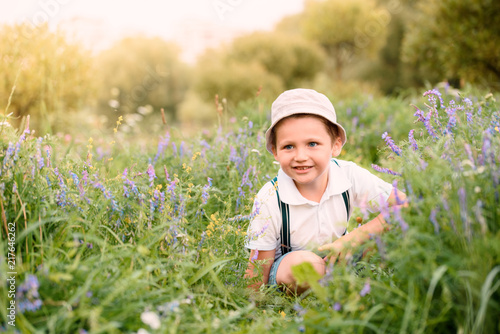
[0,24,93,132]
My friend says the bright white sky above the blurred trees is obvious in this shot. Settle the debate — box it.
[0,0,305,61]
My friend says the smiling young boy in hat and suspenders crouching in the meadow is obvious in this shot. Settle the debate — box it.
[246,89,405,293]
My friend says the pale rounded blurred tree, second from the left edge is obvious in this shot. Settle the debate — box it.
[97,37,190,121]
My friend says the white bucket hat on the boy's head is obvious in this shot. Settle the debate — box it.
[266,88,347,153]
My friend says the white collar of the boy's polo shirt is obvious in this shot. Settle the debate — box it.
[278,161,352,205]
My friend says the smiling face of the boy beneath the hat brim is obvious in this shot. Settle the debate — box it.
[273,117,342,191]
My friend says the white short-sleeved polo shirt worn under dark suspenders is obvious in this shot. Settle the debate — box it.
[245,160,392,258]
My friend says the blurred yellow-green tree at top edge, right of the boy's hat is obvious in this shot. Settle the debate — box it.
[302,0,390,79]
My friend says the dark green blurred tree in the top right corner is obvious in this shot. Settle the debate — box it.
[403,0,500,90]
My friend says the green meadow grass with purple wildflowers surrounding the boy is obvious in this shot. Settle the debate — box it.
[0,87,500,333]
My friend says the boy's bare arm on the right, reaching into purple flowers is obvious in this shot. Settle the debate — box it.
[318,189,408,263]
